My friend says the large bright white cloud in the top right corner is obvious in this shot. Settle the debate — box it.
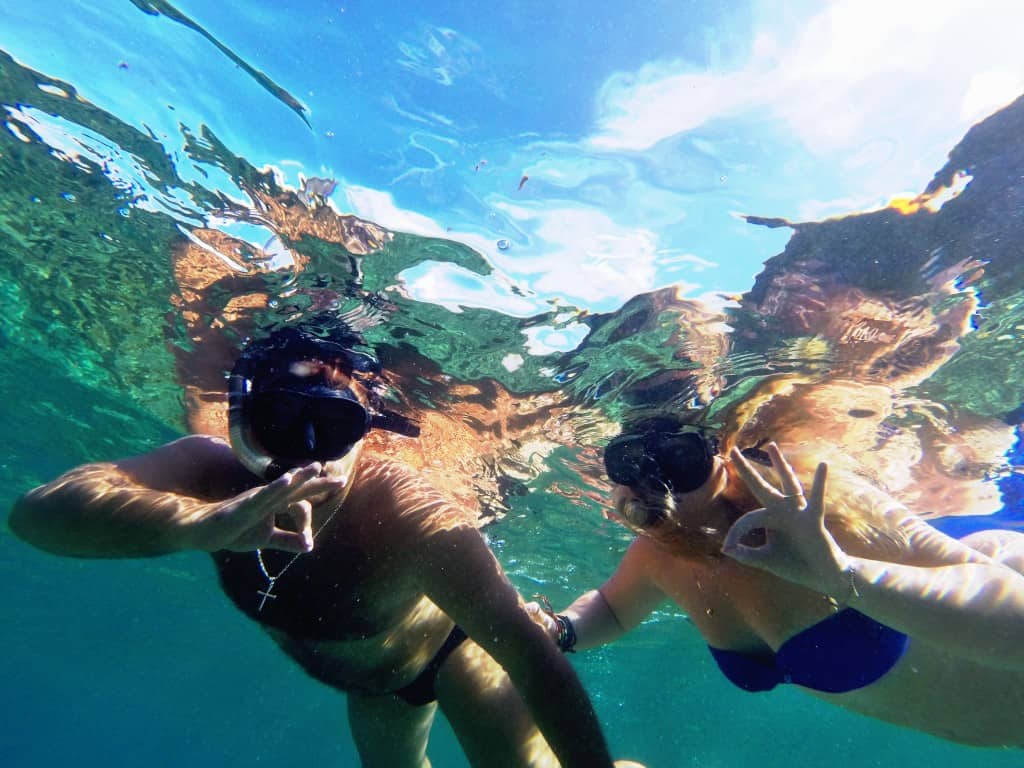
[590,0,1024,157]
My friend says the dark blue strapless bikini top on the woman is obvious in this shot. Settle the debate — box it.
[708,608,909,693]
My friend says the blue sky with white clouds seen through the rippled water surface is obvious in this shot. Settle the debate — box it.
[0,0,1024,325]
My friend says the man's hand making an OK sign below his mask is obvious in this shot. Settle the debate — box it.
[184,463,345,552]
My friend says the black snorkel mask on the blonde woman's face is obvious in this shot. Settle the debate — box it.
[604,423,718,494]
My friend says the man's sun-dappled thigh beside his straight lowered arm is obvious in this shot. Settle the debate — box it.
[434,640,558,768]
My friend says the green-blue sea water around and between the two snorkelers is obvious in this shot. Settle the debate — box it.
[6,40,1024,768]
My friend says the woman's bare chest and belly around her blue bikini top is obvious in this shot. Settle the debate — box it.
[651,548,1024,746]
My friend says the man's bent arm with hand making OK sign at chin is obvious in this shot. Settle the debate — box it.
[8,435,330,558]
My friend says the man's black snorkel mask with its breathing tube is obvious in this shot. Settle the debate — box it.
[228,328,419,480]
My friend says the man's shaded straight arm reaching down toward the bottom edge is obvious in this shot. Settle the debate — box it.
[420,526,611,768]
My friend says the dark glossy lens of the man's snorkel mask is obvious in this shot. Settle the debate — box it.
[251,390,367,465]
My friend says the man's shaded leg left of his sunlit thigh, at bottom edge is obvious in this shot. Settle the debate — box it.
[348,693,437,768]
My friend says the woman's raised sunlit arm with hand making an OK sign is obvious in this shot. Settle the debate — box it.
[723,445,1024,669]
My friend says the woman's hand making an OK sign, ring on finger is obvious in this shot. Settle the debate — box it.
[722,443,850,597]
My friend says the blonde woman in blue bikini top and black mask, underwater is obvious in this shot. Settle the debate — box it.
[530,416,1024,746]
